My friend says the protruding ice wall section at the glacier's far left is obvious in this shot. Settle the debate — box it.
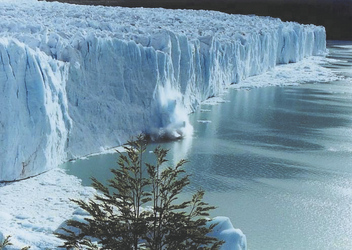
[0,39,71,181]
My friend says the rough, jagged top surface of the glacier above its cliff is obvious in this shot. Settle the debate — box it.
[0,0,314,44]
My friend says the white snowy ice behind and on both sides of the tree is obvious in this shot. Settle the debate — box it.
[0,169,247,250]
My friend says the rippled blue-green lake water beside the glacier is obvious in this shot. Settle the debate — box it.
[63,42,352,250]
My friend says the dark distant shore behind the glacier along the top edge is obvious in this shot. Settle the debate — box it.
[42,0,352,40]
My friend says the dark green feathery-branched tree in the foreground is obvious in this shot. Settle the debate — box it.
[56,135,223,250]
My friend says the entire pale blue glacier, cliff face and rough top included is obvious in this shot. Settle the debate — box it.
[0,0,326,181]
